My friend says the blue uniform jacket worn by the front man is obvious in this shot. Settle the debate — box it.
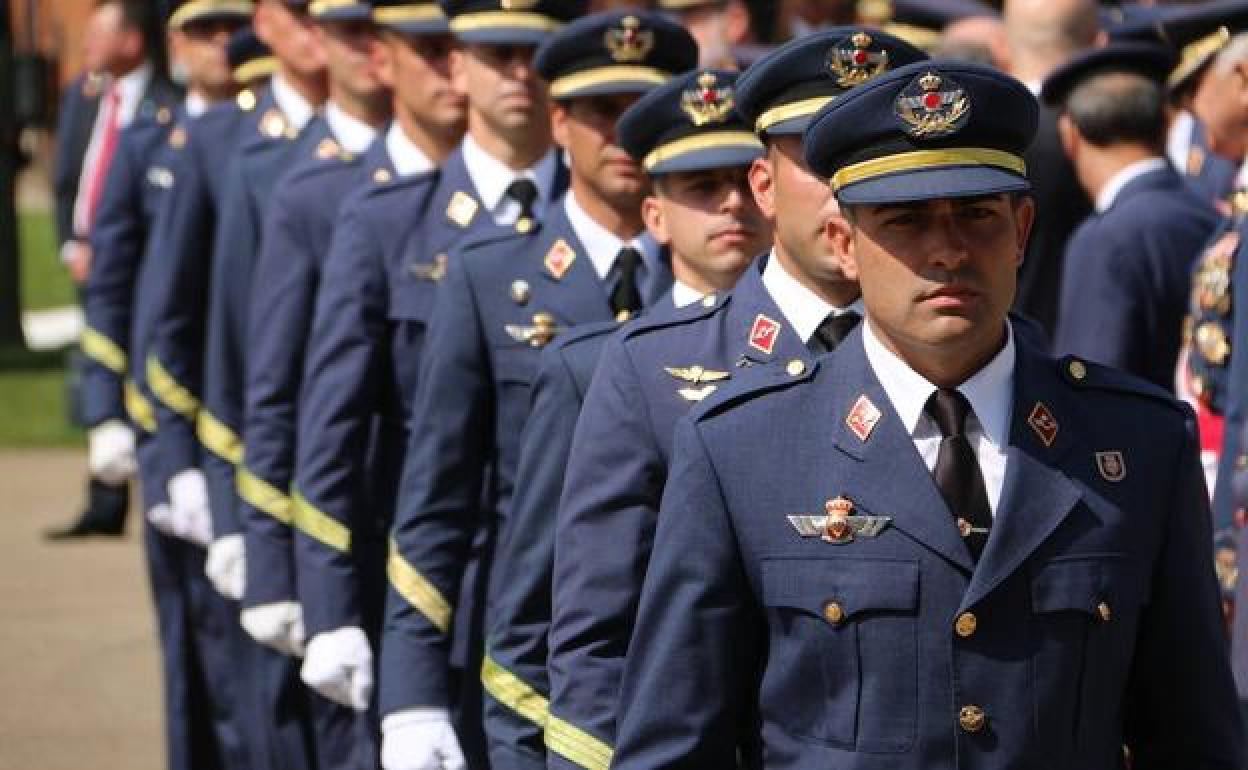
[612,321,1244,770]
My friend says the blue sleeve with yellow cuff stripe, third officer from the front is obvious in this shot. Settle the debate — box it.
[480,319,616,770]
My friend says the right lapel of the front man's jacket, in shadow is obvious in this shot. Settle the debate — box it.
[962,334,1080,607]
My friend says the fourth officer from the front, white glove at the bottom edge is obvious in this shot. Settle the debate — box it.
[382,11,696,768]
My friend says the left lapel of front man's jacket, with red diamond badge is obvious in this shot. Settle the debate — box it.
[821,326,972,573]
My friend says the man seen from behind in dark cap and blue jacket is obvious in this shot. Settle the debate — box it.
[1043,42,1217,392]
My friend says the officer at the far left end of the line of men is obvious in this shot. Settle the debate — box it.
[84,2,255,770]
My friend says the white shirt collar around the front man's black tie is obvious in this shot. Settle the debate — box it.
[862,318,1015,517]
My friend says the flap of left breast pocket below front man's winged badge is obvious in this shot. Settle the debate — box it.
[763,558,919,618]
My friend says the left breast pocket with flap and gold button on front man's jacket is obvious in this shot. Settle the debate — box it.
[761,558,919,753]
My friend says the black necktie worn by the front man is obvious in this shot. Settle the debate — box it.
[924,388,992,560]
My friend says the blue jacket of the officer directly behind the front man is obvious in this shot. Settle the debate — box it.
[547,260,810,769]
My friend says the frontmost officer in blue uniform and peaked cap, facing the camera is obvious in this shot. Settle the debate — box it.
[613,62,1244,770]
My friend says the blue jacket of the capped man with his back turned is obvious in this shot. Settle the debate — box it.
[1053,166,1218,392]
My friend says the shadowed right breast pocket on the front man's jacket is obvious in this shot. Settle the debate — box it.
[1031,554,1146,749]
